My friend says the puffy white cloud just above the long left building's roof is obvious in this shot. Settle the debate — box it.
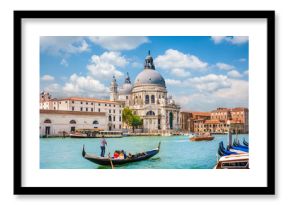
[62,74,109,97]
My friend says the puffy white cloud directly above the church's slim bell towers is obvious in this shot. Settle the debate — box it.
[87,51,128,79]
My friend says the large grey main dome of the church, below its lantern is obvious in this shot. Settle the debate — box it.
[135,69,166,87]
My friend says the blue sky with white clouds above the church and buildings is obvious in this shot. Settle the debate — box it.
[40,36,249,111]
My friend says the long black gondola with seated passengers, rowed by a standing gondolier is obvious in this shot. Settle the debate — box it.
[82,142,160,166]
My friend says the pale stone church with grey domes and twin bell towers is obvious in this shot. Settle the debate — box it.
[110,51,180,132]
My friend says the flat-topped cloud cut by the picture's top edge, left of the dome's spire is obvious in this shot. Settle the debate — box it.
[90,36,149,51]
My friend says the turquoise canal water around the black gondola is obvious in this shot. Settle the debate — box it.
[40,135,248,169]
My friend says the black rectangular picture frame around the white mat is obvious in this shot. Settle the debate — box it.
[14,11,275,195]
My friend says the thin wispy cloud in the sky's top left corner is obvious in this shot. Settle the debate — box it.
[40,36,89,55]
